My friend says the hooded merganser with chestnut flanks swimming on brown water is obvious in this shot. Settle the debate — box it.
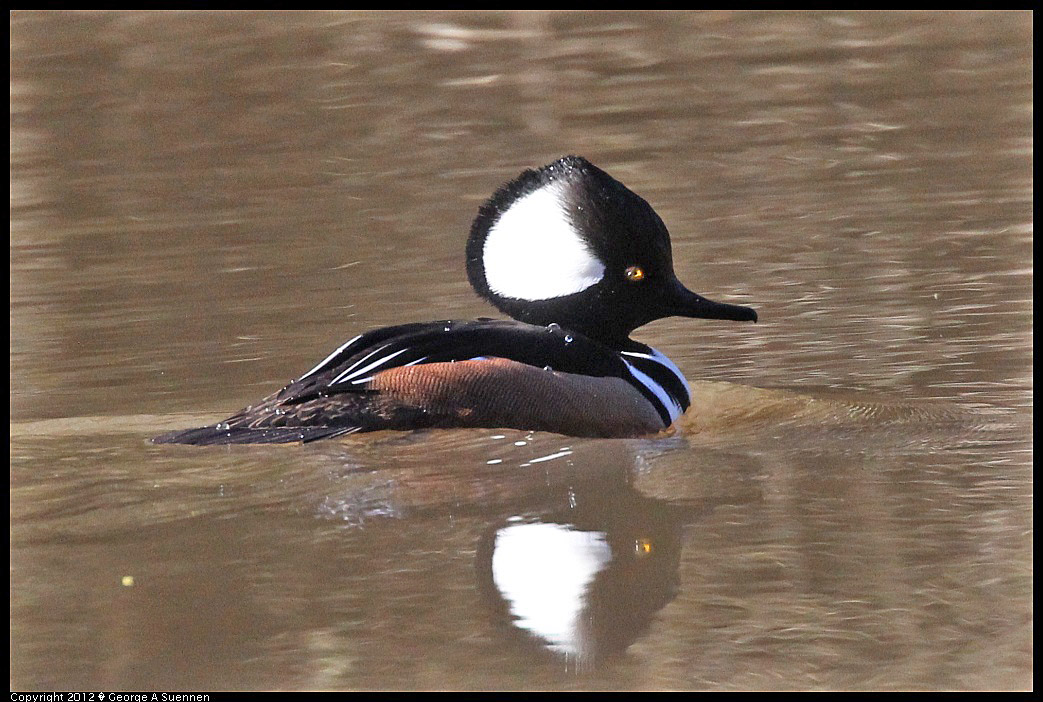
[153,156,757,444]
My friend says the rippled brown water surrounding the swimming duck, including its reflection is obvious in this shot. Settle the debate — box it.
[10,11,1033,691]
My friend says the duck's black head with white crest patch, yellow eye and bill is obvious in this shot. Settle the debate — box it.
[467,156,757,343]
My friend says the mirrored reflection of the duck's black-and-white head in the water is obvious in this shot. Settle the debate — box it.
[478,473,706,664]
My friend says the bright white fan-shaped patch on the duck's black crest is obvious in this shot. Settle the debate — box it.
[482,183,605,299]
